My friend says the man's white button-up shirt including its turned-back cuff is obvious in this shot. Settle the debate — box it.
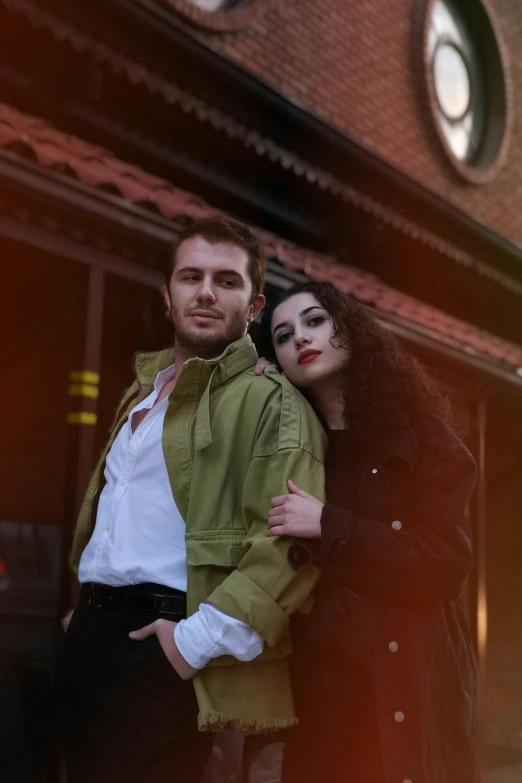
[78,365,263,669]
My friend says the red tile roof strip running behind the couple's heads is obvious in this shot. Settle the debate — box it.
[0,104,522,374]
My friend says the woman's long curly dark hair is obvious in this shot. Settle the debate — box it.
[260,283,453,451]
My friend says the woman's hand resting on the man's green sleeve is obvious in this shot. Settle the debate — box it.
[268,479,324,538]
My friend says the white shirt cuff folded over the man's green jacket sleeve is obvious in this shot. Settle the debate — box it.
[174,604,264,669]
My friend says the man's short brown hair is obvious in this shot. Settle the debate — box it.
[167,215,266,301]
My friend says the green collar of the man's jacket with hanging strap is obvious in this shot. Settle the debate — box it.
[135,334,257,451]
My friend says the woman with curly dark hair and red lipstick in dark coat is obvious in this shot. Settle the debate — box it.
[257,283,478,783]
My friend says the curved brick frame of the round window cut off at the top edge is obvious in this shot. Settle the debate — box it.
[157,0,275,33]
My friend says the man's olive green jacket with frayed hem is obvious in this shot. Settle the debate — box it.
[71,336,326,733]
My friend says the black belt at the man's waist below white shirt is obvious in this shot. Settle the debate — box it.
[80,582,187,621]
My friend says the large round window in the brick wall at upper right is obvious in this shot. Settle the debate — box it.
[425,0,507,182]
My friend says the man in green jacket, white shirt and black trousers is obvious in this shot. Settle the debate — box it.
[56,218,325,783]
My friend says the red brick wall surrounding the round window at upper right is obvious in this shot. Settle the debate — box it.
[186,0,522,247]
